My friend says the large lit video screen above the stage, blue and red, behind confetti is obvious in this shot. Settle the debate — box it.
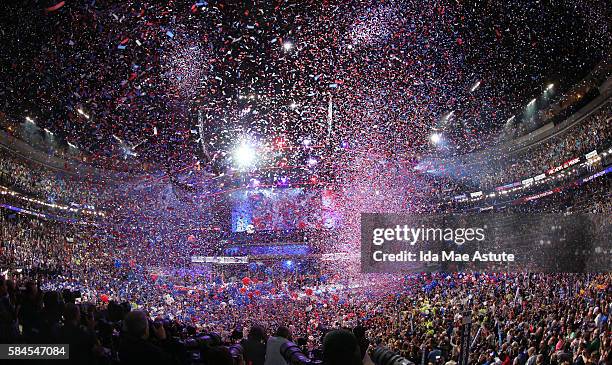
[232,188,338,232]
